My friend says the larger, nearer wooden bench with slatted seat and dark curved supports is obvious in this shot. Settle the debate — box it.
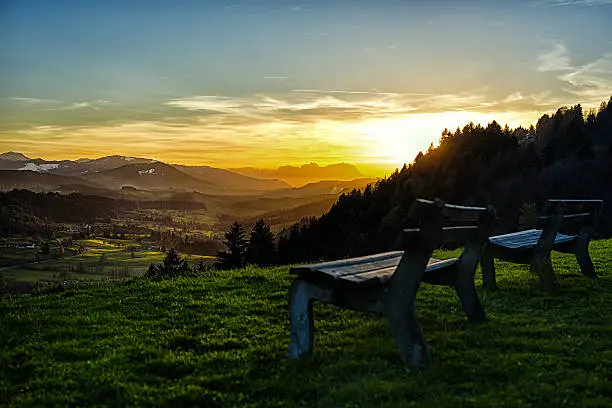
[289,199,495,367]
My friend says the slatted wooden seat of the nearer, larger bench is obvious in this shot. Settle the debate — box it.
[291,251,459,287]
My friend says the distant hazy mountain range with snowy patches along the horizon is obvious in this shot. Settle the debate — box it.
[0,152,375,197]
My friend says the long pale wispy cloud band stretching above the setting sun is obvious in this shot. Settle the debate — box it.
[165,89,497,123]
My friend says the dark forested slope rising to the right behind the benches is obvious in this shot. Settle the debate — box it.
[278,98,612,263]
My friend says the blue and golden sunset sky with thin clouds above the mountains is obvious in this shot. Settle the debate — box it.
[0,0,612,173]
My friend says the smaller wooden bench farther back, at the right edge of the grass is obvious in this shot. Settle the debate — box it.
[480,200,603,292]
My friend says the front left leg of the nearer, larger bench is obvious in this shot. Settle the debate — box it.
[289,278,330,359]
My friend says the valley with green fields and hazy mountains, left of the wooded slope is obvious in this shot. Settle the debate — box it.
[0,152,377,289]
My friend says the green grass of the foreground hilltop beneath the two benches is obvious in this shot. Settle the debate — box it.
[0,240,612,407]
